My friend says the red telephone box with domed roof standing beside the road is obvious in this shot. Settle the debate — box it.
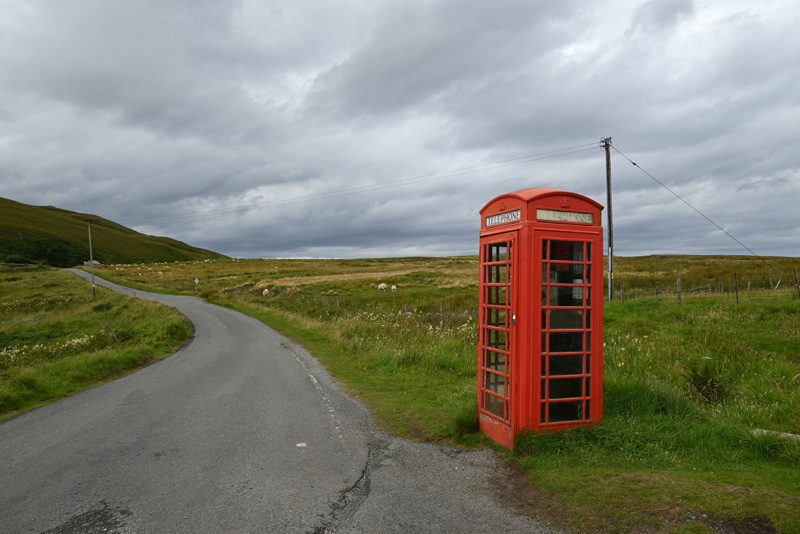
[478,189,603,449]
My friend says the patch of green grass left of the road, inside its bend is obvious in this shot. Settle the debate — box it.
[0,267,191,419]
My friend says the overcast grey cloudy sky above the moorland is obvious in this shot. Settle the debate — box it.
[0,0,800,258]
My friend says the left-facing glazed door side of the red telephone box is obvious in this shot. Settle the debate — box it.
[478,232,519,448]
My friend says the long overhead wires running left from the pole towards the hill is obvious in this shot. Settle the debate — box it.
[122,143,597,224]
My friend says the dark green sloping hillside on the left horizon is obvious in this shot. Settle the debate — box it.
[0,198,225,267]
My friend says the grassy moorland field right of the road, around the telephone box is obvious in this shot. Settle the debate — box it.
[84,256,800,533]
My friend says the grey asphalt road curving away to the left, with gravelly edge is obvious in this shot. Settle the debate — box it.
[0,270,555,534]
